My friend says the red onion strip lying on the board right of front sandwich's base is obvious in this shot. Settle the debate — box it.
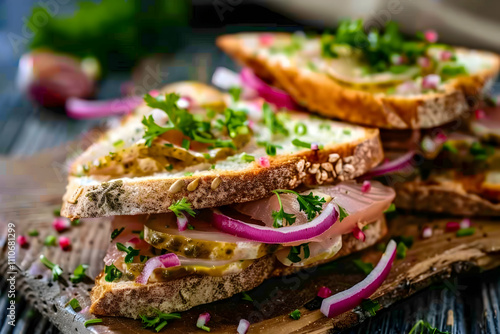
[321,240,397,318]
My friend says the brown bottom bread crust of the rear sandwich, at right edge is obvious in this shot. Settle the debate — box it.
[394,180,500,217]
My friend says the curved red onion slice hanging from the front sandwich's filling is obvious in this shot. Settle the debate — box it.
[212,202,339,244]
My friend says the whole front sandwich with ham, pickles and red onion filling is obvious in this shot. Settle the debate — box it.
[61,82,395,322]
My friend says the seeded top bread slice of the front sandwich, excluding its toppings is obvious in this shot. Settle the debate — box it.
[61,83,383,218]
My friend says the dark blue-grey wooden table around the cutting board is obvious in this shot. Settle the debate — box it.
[0,37,500,334]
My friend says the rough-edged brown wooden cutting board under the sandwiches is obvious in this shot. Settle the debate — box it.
[0,144,500,333]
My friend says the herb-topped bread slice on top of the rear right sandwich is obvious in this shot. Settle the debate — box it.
[217,20,500,129]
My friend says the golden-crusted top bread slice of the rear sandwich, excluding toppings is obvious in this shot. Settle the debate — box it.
[217,33,500,129]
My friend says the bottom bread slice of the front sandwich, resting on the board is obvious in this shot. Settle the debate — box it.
[90,218,387,319]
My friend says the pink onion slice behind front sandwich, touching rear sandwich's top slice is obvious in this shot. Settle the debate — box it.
[240,68,299,110]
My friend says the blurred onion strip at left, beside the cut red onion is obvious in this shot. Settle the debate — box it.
[66,96,143,119]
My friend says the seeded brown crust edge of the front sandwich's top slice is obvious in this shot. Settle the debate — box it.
[61,129,383,219]
